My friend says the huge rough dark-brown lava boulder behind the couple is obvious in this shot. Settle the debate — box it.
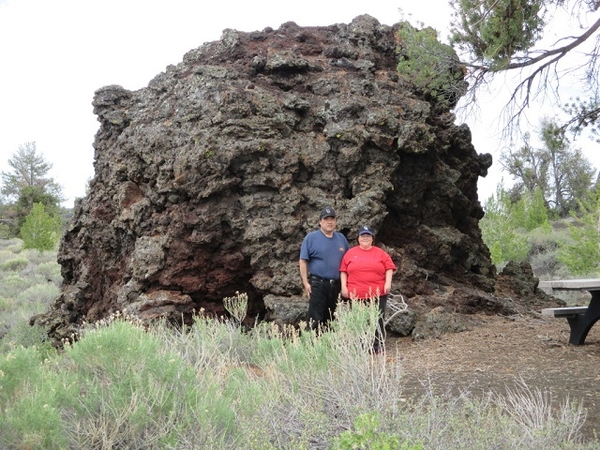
[34,16,556,342]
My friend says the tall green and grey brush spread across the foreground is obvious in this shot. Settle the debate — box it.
[0,296,597,450]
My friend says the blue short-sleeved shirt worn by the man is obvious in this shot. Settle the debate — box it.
[300,230,349,280]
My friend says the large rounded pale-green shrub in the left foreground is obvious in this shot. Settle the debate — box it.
[59,320,218,448]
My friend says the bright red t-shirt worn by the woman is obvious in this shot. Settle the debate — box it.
[340,245,396,299]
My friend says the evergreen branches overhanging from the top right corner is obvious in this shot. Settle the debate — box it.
[450,0,600,131]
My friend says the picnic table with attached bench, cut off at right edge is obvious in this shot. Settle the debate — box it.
[538,278,600,345]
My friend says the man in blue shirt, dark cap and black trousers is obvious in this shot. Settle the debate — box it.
[299,206,349,329]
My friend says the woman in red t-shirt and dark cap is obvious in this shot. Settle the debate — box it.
[340,225,396,353]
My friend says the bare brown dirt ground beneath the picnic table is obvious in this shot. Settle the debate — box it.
[387,316,600,440]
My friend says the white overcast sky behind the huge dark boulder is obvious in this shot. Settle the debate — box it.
[0,0,600,207]
